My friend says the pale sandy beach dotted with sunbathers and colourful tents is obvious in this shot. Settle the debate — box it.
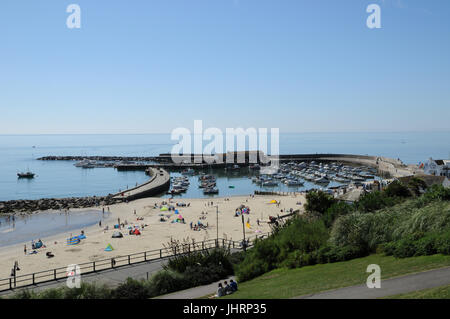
[0,194,305,278]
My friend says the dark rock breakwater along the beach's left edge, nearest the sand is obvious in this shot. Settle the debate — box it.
[0,196,121,214]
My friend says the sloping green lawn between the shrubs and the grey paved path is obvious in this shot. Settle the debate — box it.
[223,255,450,299]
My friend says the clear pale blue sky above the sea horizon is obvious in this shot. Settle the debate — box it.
[0,0,450,134]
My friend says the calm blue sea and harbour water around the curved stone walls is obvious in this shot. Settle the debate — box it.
[0,132,450,201]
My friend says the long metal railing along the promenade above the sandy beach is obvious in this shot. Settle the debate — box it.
[0,233,270,292]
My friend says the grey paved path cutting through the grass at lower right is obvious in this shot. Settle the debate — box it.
[294,267,450,299]
